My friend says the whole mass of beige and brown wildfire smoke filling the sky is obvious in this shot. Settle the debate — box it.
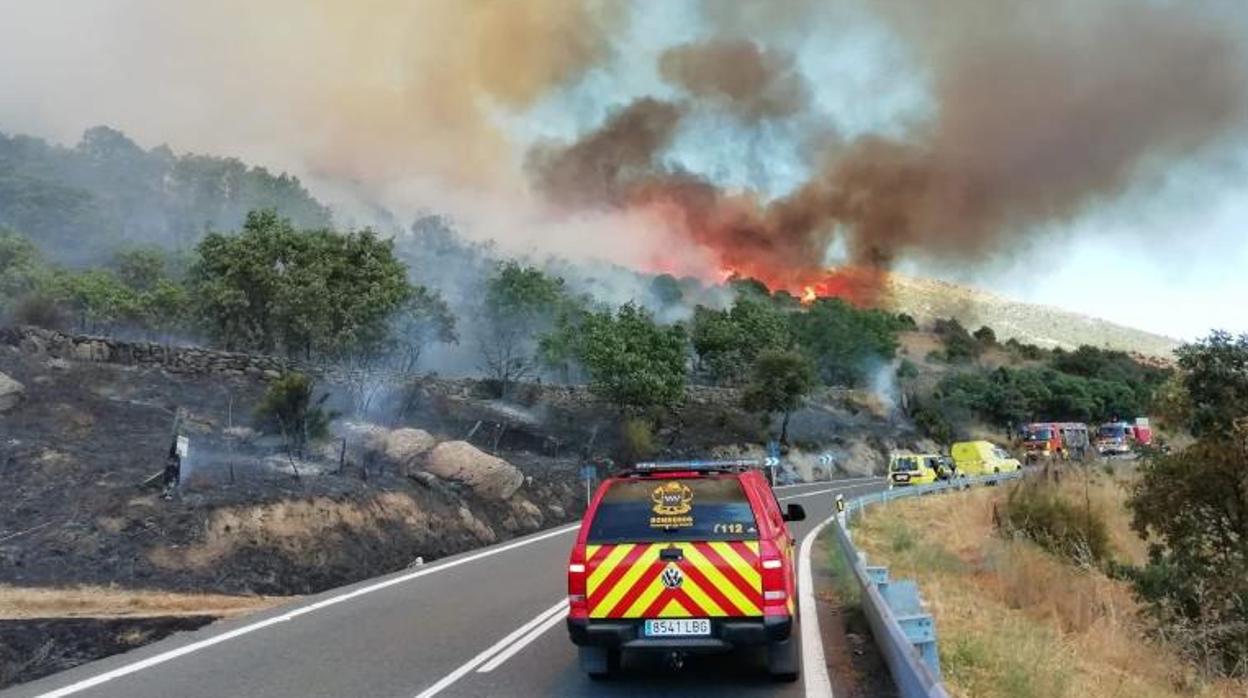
[0,0,1248,304]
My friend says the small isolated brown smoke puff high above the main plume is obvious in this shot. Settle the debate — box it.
[659,39,810,120]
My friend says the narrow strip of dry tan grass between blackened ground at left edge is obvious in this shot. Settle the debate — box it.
[0,586,288,619]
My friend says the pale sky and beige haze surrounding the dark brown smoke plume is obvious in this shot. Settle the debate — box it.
[0,0,1248,338]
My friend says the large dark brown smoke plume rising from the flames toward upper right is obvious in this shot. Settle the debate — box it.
[521,0,1246,305]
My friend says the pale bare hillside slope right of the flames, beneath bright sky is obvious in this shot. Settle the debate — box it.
[890,273,1179,356]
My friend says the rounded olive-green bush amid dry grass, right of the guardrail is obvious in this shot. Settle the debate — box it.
[997,482,1109,564]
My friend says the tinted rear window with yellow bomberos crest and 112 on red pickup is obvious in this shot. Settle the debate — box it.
[588,478,759,543]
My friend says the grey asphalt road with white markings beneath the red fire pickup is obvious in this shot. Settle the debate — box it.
[7,478,884,698]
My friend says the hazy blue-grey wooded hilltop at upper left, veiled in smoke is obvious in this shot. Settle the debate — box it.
[0,126,331,263]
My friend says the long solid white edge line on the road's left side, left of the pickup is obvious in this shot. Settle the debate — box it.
[37,523,580,698]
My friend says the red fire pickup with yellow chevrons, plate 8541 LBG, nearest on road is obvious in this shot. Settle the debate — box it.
[568,461,806,681]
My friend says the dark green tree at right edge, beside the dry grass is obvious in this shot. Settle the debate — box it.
[1128,332,1248,676]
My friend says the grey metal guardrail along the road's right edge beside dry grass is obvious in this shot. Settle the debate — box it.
[832,471,1022,698]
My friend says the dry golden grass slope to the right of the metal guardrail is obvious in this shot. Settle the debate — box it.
[855,473,1248,698]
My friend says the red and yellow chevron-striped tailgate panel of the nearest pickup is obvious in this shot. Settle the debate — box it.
[585,541,763,618]
